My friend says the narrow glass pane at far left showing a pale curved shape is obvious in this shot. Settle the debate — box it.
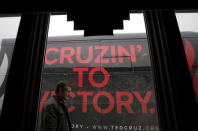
[0,16,20,114]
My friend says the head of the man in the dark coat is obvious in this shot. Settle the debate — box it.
[55,81,71,99]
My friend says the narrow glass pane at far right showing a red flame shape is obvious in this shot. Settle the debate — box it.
[176,13,198,101]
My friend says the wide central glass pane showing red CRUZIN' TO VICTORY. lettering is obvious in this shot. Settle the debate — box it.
[38,13,159,131]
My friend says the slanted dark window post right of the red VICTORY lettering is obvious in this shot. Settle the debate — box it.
[144,10,198,131]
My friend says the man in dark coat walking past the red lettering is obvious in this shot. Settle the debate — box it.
[39,82,71,131]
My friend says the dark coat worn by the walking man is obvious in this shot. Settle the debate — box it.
[39,96,71,131]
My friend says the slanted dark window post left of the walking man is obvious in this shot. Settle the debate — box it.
[0,13,50,131]
